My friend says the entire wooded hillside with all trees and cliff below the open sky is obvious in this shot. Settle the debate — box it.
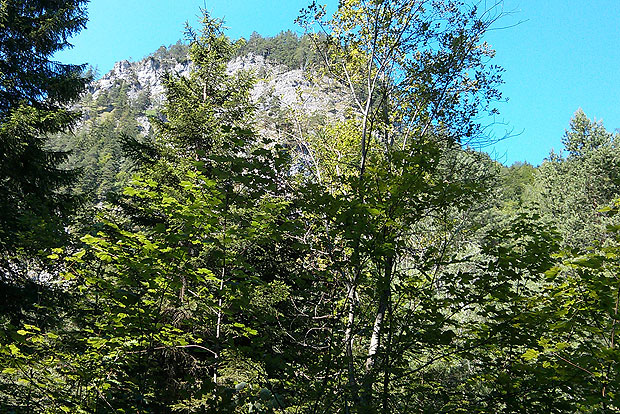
[0,0,620,414]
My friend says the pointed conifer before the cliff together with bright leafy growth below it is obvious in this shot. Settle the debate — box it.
[0,11,298,413]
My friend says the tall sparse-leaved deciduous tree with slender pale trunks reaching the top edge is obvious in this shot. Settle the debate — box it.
[300,0,501,413]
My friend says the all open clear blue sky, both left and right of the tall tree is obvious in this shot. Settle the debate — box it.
[57,0,620,165]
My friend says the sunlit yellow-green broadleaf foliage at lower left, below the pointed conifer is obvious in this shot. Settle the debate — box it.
[3,164,296,412]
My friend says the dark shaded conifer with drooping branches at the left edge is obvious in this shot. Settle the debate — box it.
[0,0,88,258]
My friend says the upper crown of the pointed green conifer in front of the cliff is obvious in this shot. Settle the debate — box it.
[152,14,253,173]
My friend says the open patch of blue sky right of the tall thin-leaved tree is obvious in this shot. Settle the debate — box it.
[487,0,620,164]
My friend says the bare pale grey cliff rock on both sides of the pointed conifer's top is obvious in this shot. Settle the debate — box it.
[88,49,347,134]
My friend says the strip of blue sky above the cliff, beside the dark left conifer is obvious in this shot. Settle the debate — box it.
[57,0,338,74]
